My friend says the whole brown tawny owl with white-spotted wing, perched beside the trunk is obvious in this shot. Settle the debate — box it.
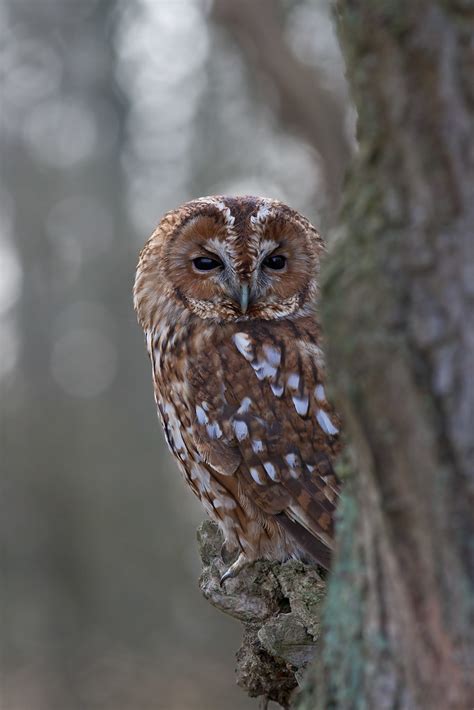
[134,196,340,580]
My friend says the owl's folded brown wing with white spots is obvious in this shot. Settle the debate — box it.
[191,322,339,567]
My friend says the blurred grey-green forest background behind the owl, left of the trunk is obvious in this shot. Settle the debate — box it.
[0,0,354,710]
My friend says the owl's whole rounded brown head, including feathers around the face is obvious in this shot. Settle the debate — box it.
[134,196,324,328]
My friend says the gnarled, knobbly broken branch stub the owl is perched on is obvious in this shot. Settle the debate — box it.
[198,521,325,707]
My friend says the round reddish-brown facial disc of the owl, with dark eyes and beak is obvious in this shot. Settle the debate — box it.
[156,198,320,321]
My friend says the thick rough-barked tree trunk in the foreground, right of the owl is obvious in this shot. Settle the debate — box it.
[298,0,474,710]
